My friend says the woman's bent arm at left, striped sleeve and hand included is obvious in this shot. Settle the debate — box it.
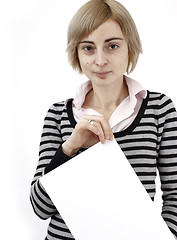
[30,101,113,219]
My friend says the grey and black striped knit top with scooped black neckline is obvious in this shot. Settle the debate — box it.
[30,91,177,240]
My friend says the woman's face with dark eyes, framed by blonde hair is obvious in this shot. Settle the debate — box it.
[78,20,128,86]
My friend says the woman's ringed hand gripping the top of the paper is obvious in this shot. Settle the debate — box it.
[62,115,114,156]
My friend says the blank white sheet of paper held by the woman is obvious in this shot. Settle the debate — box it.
[41,140,174,240]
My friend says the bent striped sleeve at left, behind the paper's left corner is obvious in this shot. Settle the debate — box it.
[30,104,69,219]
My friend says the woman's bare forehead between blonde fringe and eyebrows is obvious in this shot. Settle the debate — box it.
[82,20,124,41]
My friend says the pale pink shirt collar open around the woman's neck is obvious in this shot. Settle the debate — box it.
[73,76,147,132]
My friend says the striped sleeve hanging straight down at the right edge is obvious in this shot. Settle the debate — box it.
[158,96,177,237]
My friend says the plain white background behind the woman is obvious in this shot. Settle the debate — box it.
[0,0,177,240]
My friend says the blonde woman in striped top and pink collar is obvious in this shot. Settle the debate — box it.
[31,0,177,240]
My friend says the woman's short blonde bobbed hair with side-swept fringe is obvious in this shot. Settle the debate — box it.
[67,0,142,74]
